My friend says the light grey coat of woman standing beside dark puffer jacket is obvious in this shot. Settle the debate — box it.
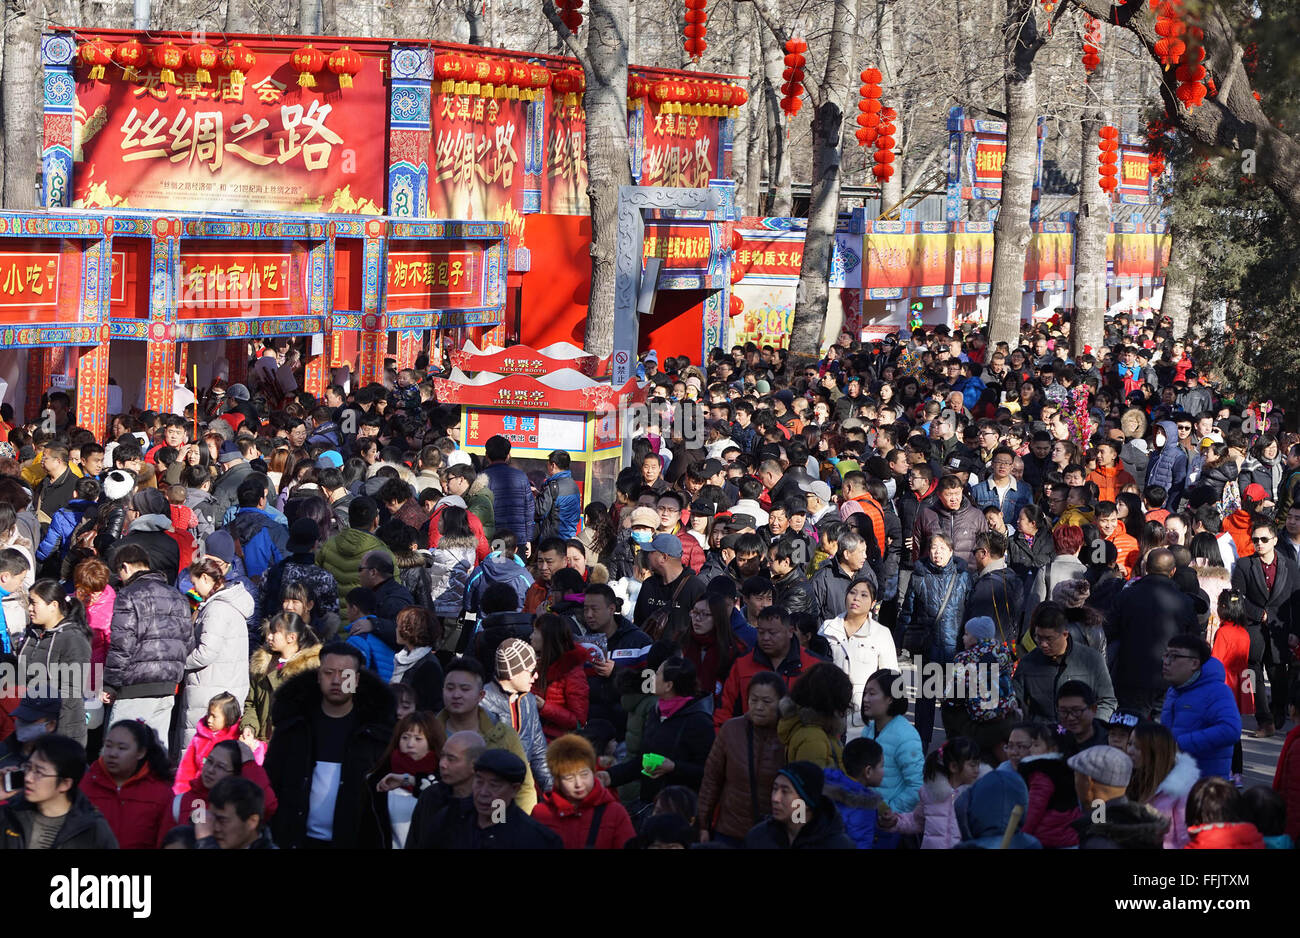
[185,583,252,743]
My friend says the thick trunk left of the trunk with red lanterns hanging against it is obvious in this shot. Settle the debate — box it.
[988,0,1043,348]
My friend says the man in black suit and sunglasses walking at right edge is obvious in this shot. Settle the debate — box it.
[1232,518,1300,737]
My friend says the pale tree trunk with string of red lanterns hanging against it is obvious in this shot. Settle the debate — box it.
[1070,30,1117,357]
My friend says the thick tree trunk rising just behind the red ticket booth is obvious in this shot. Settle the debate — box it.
[582,0,632,356]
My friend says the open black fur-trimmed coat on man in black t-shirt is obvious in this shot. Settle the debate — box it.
[258,669,397,850]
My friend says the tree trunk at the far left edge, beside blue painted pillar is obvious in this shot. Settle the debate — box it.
[0,0,42,209]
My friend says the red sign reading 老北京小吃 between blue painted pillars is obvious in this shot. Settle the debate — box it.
[177,242,307,320]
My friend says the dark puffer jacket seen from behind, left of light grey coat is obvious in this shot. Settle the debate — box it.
[104,570,195,698]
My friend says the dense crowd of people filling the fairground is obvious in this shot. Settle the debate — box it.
[0,314,1300,850]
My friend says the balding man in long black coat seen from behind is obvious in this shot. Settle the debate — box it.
[1114,548,1196,720]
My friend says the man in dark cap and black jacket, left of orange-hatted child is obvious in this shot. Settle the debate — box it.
[420,750,564,850]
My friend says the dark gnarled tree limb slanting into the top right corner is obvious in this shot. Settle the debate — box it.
[1074,0,1300,221]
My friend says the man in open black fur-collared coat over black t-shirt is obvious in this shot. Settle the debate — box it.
[265,642,397,850]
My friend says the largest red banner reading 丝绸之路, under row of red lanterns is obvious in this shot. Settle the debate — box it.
[73,40,389,214]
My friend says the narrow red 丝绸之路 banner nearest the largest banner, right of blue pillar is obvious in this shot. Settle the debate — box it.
[429,95,528,236]
